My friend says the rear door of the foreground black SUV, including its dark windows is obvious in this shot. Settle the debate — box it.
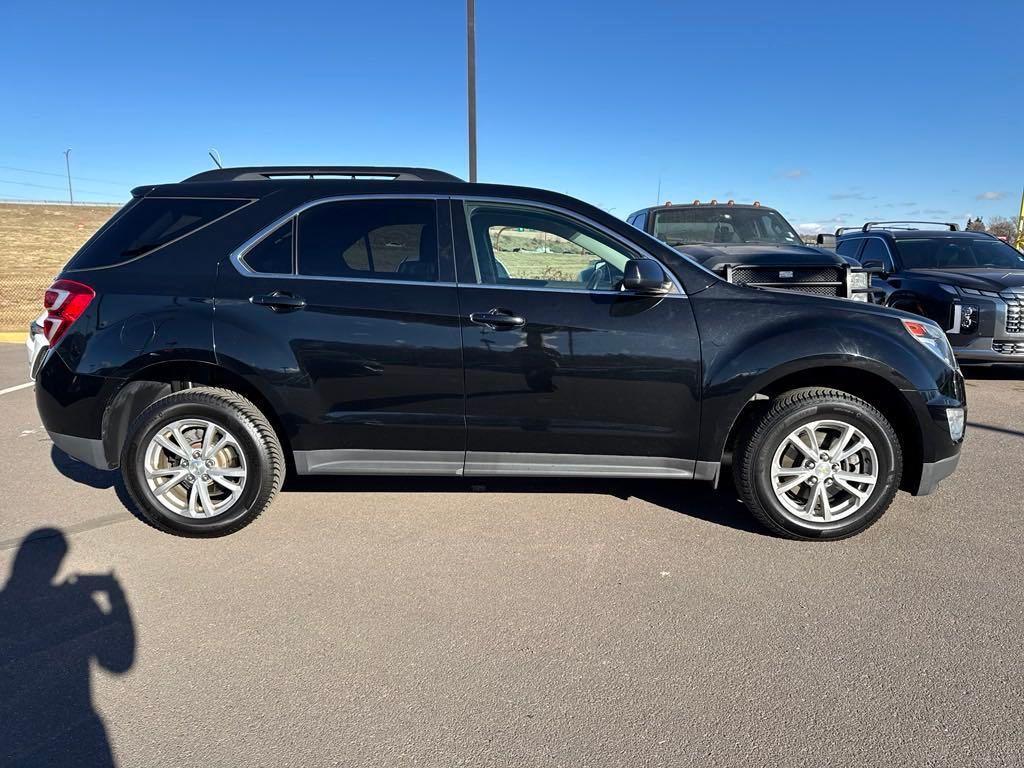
[214,196,466,474]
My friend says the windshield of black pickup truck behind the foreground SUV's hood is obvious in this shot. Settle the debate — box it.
[654,206,802,246]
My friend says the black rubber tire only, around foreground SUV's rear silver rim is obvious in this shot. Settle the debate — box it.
[121,387,285,537]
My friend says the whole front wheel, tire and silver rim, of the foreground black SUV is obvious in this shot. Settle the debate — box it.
[733,388,903,540]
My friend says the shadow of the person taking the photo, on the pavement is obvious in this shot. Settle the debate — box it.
[0,528,135,766]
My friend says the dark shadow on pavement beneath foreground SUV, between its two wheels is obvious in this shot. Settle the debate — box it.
[285,475,770,536]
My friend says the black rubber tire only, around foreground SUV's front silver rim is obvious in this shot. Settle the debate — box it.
[732,388,903,541]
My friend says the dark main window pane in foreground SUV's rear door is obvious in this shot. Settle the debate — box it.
[298,200,438,282]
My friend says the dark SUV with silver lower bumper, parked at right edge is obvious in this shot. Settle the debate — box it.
[836,221,1024,365]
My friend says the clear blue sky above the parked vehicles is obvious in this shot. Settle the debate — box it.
[0,0,1024,230]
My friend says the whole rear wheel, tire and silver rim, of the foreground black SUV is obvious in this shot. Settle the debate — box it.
[121,387,285,536]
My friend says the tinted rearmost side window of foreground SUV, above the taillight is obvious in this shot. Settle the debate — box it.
[67,198,249,270]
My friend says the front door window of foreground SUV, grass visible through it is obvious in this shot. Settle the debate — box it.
[466,203,634,291]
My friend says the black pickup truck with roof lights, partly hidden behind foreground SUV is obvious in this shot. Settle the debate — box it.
[627,200,869,301]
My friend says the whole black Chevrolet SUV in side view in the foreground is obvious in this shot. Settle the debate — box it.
[33,167,965,539]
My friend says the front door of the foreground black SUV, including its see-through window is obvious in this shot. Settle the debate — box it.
[453,199,699,477]
